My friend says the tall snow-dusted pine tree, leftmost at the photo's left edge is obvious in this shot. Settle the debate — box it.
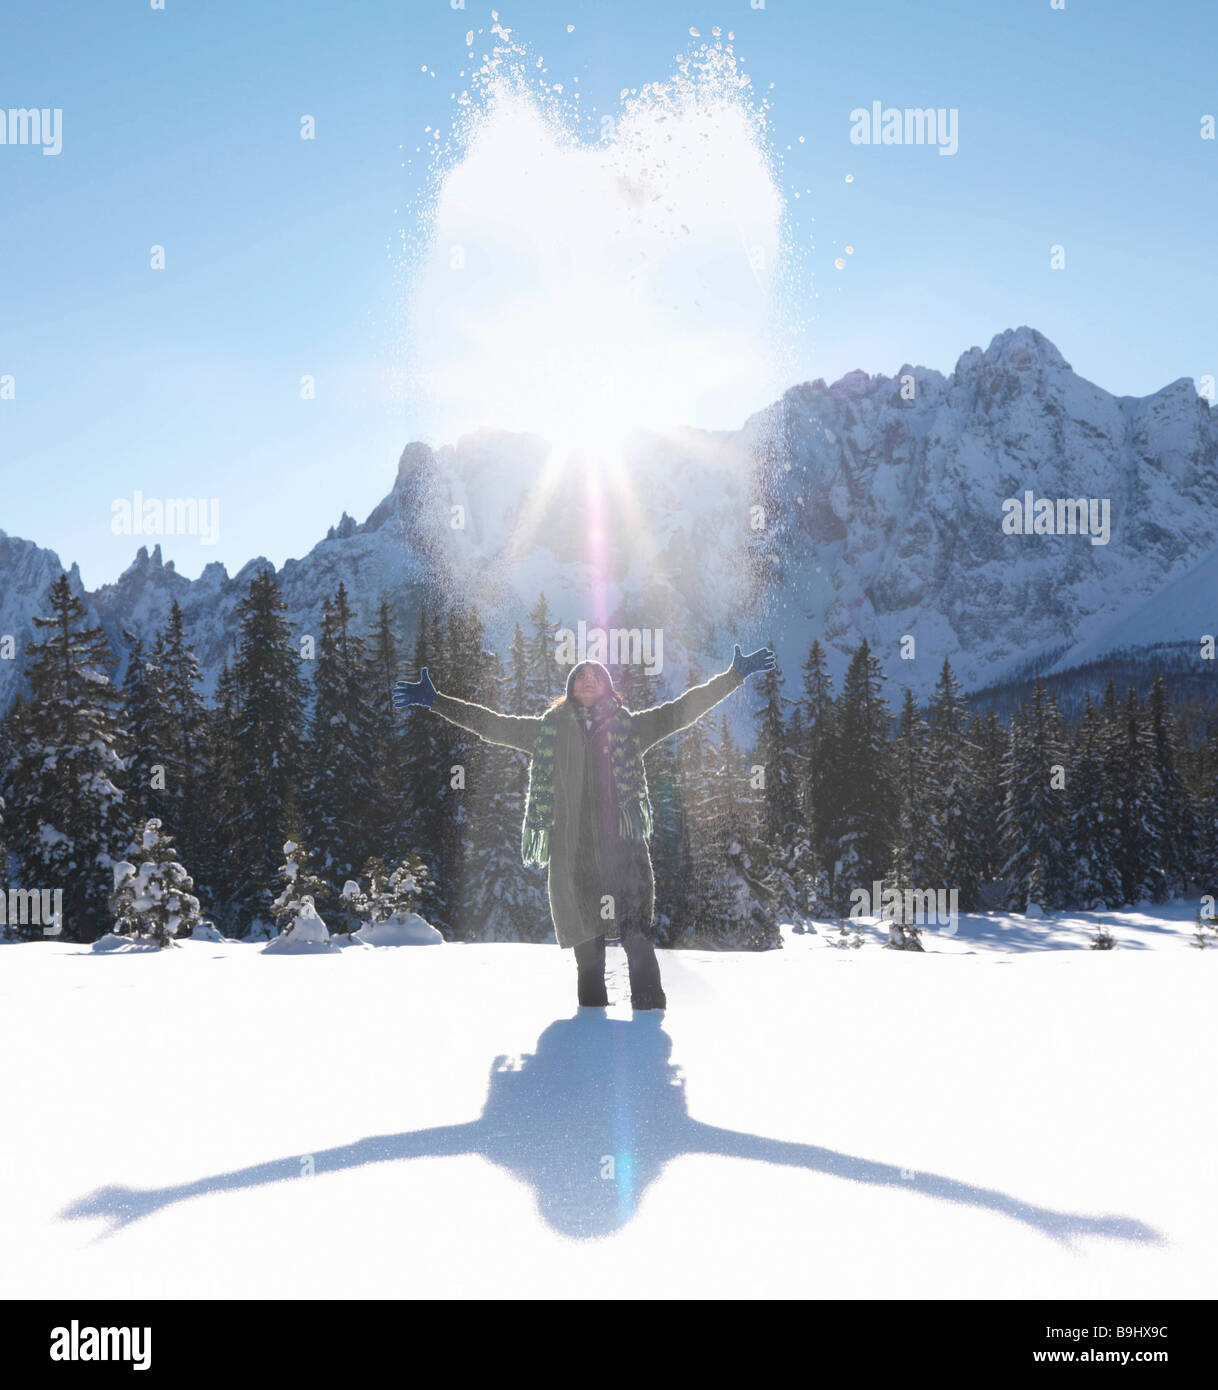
[8,574,128,942]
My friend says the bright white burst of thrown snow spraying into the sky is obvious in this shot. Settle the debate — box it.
[406,19,788,443]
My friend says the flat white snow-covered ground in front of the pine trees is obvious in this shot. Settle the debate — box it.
[0,904,1218,1300]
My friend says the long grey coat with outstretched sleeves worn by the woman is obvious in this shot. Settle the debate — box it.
[431,667,744,948]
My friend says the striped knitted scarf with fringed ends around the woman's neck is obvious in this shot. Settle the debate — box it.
[520,695,652,865]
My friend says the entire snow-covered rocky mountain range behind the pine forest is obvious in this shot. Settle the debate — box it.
[0,327,1218,706]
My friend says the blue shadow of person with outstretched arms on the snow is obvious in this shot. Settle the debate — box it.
[60,1011,1162,1244]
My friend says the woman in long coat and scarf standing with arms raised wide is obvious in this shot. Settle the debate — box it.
[393,646,774,1009]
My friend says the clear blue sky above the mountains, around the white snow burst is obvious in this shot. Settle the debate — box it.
[0,0,1218,586]
